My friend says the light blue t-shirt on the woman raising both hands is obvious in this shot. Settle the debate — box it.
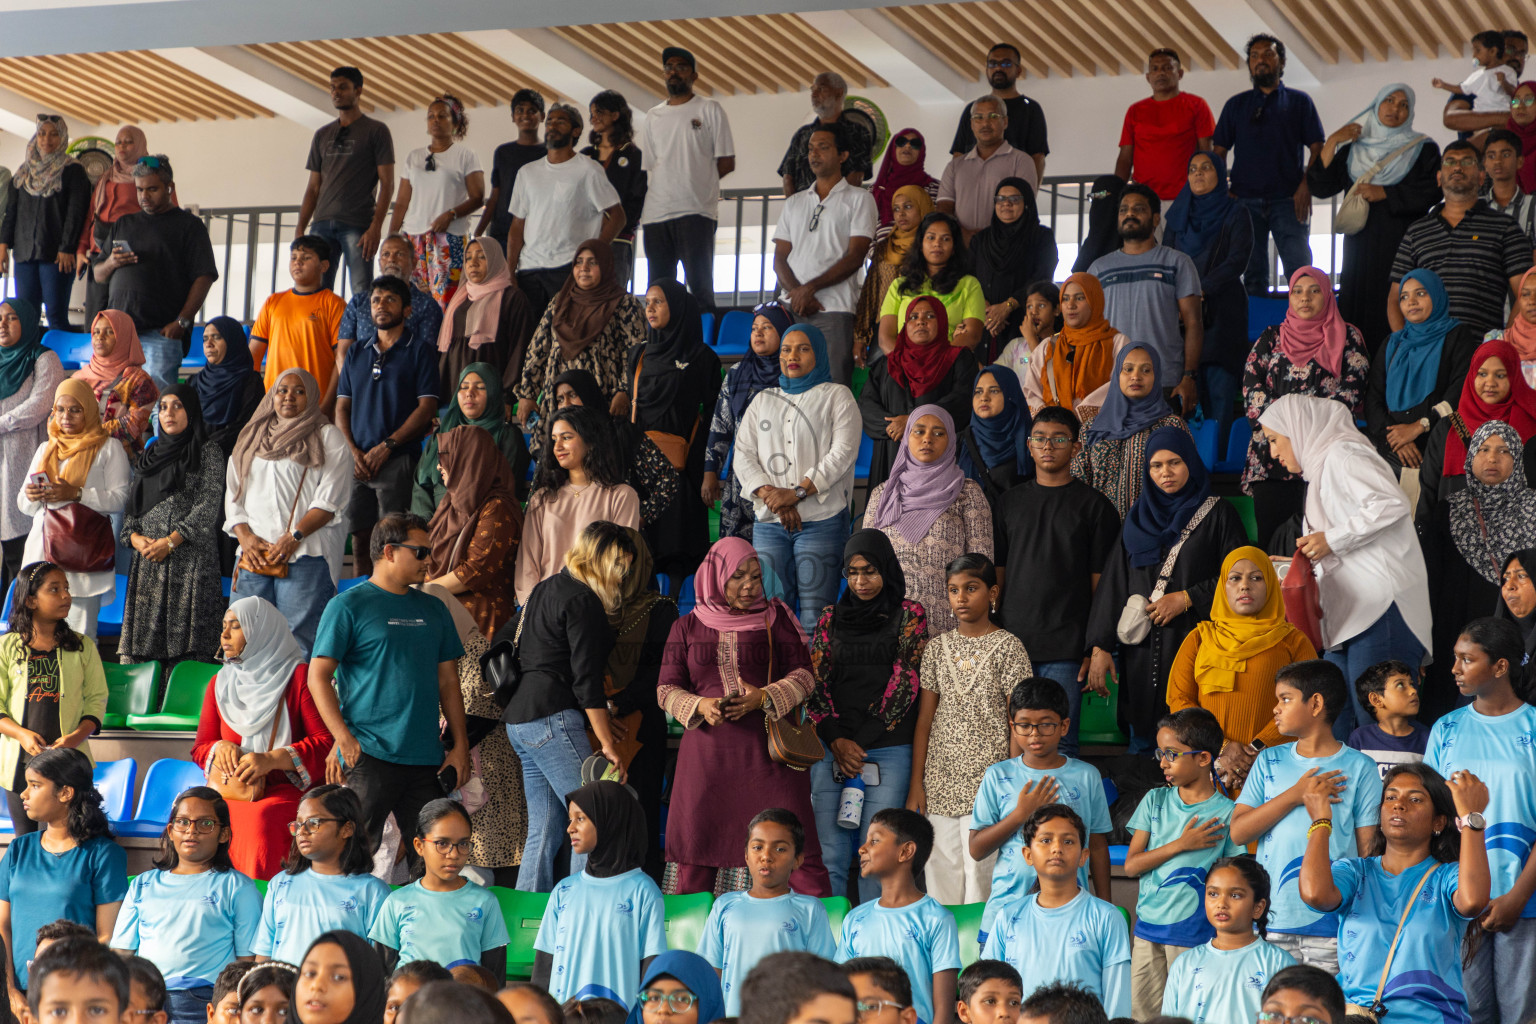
[1333,859,1468,1024]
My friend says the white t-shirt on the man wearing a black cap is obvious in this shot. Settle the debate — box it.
[637,97,736,224]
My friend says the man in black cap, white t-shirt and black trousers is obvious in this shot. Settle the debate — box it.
[634,46,736,312]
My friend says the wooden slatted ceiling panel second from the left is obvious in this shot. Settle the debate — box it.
[244,32,556,111]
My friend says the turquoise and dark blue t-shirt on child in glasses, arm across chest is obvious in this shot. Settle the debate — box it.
[1126,786,1243,947]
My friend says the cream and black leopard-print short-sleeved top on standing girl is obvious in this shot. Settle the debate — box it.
[922,629,1034,818]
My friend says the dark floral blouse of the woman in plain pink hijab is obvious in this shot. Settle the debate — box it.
[1243,324,1370,494]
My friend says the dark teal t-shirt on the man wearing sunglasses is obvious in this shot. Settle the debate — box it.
[313,582,464,765]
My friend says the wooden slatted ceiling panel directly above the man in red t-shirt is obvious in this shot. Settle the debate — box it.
[880,0,1234,81]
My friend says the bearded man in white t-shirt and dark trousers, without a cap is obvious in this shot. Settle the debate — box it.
[507,103,624,322]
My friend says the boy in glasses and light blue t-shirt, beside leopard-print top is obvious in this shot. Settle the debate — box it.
[971,679,1112,944]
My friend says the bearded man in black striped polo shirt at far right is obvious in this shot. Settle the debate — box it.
[1387,141,1531,338]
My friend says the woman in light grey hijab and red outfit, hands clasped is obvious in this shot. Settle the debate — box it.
[192,597,332,884]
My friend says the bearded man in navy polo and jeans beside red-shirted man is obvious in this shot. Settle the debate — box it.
[1212,35,1324,295]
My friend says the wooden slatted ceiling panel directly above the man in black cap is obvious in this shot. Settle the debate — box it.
[553,14,886,95]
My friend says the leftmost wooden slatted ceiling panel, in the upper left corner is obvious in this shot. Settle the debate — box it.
[0,51,272,126]
